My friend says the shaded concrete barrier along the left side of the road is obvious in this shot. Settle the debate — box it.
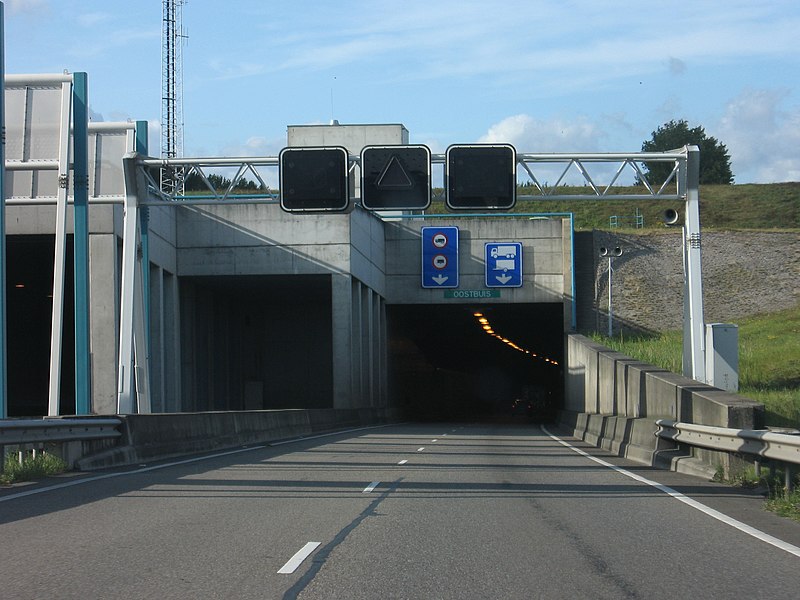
[73,409,394,471]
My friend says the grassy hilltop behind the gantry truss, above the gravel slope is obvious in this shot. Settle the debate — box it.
[427,182,800,230]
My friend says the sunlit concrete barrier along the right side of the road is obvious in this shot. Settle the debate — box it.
[558,334,764,476]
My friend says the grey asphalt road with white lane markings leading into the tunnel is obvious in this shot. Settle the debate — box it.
[0,424,800,600]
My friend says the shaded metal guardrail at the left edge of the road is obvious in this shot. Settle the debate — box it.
[0,417,122,473]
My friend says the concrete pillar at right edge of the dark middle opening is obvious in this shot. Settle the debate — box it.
[331,273,358,408]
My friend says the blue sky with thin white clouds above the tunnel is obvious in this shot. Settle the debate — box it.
[4,0,800,183]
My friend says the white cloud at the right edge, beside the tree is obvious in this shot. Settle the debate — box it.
[714,89,800,183]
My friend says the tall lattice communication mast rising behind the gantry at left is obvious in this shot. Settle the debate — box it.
[161,0,186,195]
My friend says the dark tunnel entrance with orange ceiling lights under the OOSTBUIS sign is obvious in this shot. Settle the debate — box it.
[387,303,564,421]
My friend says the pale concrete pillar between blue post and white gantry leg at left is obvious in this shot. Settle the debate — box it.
[89,233,120,415]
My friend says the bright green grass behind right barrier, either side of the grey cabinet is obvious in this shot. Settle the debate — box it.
[593,305,800,428]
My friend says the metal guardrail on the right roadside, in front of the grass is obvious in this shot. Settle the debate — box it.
[656,419,800,489]
